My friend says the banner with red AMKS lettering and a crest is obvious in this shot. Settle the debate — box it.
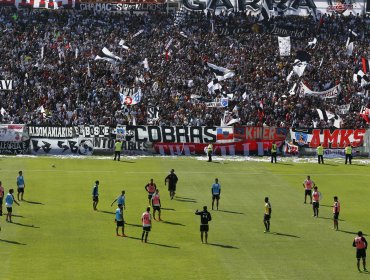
[290,129,366,149]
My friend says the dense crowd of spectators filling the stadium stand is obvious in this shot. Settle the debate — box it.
[0,7,370,128]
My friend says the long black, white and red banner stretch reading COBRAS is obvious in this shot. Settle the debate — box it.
[114,126,288,155]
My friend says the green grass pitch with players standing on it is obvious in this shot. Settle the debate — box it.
[0,157,370,280]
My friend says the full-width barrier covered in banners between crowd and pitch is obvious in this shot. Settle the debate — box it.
[0,124,370,158]
